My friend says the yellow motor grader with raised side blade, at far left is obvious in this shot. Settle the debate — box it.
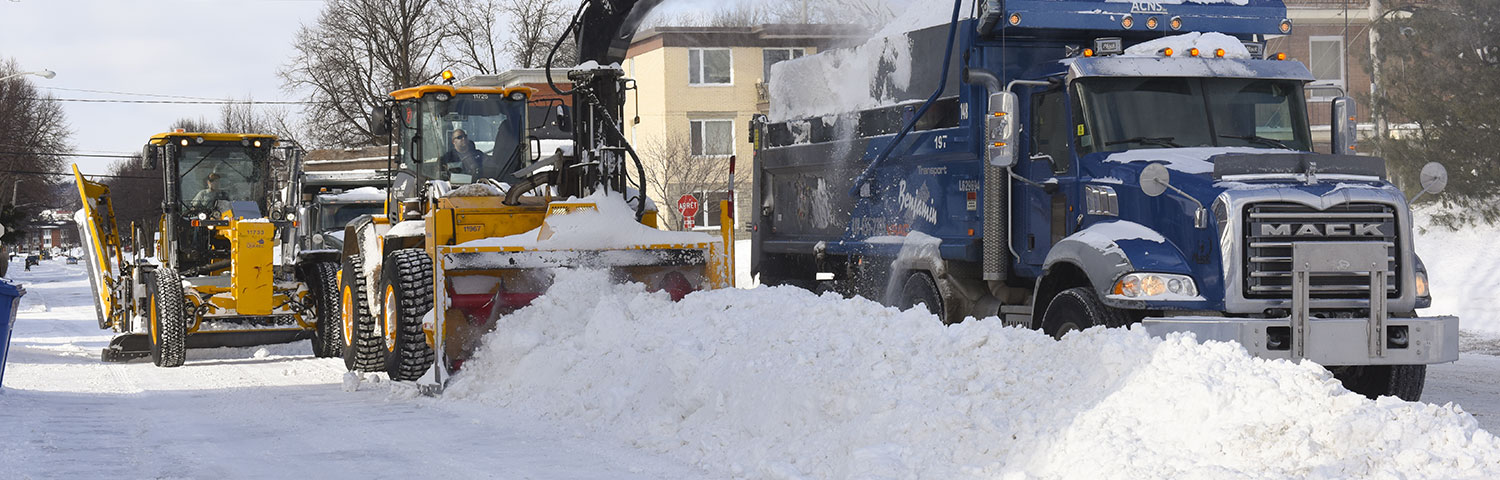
[74,131,341,368]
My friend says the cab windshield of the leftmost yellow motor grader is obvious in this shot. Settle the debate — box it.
[177,143,266,213]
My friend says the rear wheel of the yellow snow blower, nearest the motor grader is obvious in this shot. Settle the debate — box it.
[339,255,386,372]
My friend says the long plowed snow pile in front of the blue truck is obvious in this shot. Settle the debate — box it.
[447,272,1500,479]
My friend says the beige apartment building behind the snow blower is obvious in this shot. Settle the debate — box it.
[621,24,857,231]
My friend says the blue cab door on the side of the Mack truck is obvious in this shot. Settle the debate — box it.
[1014,84,1077,267]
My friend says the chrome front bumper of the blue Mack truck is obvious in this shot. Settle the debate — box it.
[1142,317,1458,366]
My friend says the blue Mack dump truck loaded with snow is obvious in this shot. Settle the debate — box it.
[750,0,1458,401]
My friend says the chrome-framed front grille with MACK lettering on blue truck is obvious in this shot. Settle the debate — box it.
[1244,203,1401,299]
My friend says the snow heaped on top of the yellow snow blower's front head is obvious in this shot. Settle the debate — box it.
[458,192,717,249]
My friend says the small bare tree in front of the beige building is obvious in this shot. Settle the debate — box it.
[641,134,750,230]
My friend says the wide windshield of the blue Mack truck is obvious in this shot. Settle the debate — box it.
[1077,77,1311,153]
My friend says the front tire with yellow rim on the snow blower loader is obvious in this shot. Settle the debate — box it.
[380,249,432,381]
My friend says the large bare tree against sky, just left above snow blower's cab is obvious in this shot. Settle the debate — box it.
[279,0,450,147]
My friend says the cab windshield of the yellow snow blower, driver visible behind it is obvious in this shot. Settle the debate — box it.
[408,93,527,183]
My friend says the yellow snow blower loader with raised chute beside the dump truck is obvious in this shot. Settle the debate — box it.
[341,2,734,392]
